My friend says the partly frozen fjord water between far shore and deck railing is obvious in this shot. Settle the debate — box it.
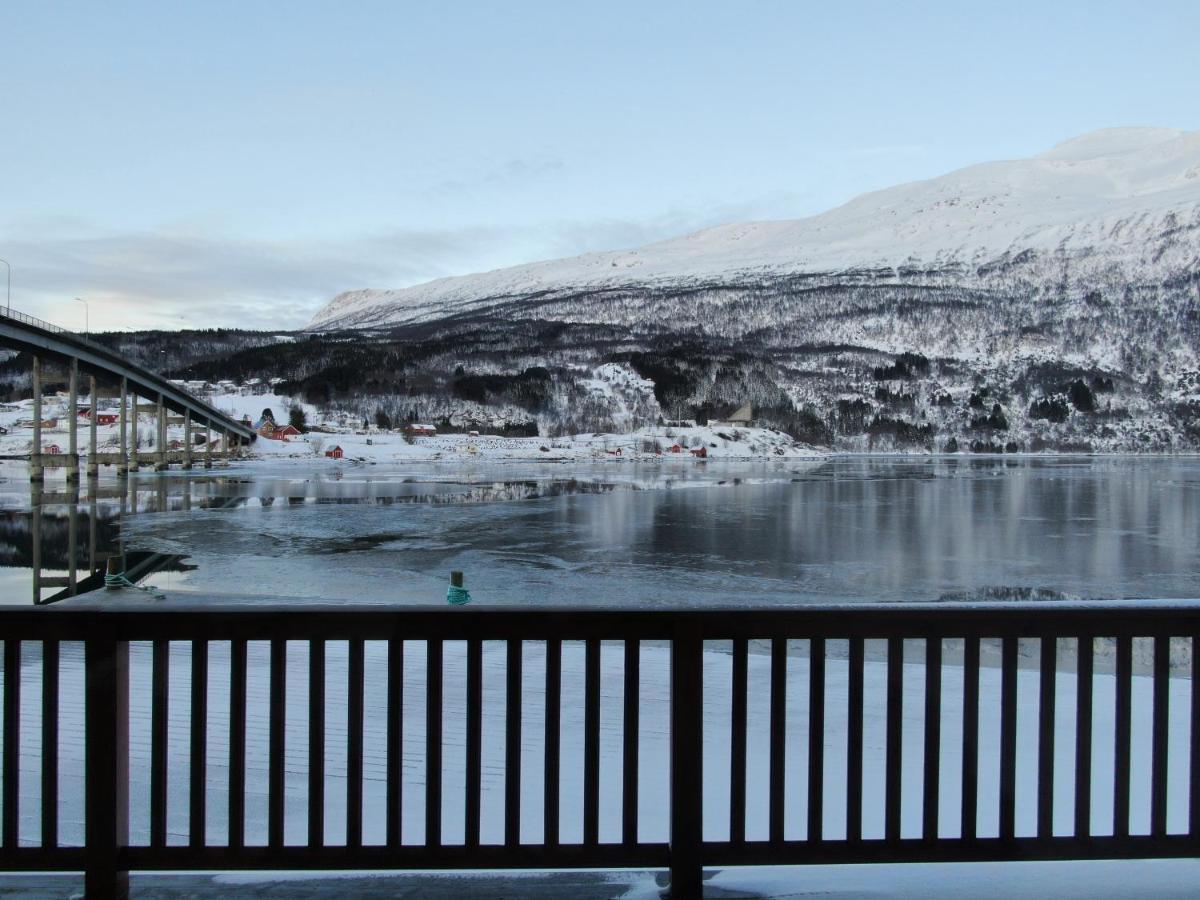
[0,456,1200,606]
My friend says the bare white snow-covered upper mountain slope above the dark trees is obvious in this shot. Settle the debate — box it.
[310,128,1200,329]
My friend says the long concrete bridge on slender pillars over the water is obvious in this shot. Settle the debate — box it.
[0,308,257,481]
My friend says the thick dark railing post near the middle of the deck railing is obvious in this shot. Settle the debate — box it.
[667,618,704,900]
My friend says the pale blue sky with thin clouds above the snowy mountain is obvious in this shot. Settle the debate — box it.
[0,0,1200,331]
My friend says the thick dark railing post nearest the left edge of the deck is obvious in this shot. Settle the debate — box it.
[84,634,130,900]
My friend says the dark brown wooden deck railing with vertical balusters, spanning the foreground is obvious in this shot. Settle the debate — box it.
[0,601,1200,896]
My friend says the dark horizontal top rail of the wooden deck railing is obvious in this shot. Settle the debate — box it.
[0,599,1200,640]
